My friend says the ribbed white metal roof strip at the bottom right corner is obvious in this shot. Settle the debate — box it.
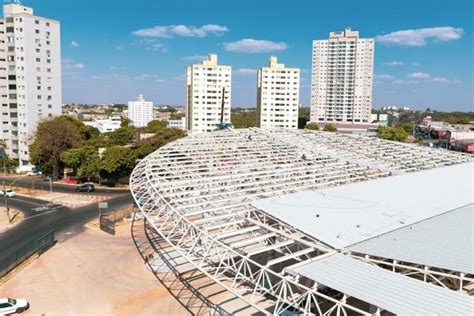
[291,254,474,315]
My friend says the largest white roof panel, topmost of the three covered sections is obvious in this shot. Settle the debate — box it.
[252,163,474,249]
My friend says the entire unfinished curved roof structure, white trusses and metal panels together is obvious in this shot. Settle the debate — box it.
[130,128,474,315]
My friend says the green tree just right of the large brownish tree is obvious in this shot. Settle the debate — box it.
[61,145,100,179]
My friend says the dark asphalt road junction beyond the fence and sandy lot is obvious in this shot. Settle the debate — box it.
[0,192,133,259]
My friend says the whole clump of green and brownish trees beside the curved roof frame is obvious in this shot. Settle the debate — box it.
[30,115,185,184]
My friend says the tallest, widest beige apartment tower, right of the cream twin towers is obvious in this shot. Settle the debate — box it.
[310,28,374,124]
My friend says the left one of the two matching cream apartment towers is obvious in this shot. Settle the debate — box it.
[185,54,232,134]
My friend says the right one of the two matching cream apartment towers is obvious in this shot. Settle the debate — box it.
[257,57,300,129]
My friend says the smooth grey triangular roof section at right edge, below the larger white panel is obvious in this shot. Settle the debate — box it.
[348,204,474,274]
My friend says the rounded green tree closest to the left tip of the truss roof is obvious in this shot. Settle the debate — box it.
[99,146,137,182]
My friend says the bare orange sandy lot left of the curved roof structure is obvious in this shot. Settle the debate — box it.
[0,225,188,315]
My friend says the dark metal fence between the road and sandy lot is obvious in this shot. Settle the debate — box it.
[0,230,56,278]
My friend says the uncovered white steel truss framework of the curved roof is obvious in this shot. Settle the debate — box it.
[130,129,470,315]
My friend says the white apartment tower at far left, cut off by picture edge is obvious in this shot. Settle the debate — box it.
[0,2,62,171]
